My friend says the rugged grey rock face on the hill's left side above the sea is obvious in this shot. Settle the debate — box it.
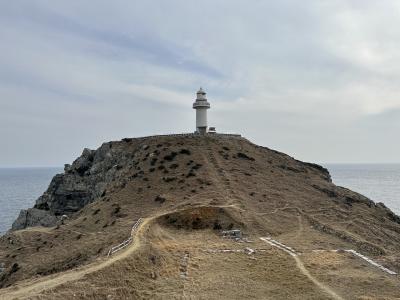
[12,142,134,230]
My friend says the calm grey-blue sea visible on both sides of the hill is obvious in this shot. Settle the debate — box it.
[0,164,400,235]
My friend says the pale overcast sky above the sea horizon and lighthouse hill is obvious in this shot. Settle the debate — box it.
[0,0,400,167]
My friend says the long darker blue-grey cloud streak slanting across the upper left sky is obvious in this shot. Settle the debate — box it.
[2,2,222,78]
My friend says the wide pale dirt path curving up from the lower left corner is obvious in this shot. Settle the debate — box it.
[0,219,150,299]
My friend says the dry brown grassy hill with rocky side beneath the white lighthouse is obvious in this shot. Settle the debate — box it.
[0,135,400,299]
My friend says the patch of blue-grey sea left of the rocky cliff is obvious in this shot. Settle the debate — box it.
[0,168,62,235]
